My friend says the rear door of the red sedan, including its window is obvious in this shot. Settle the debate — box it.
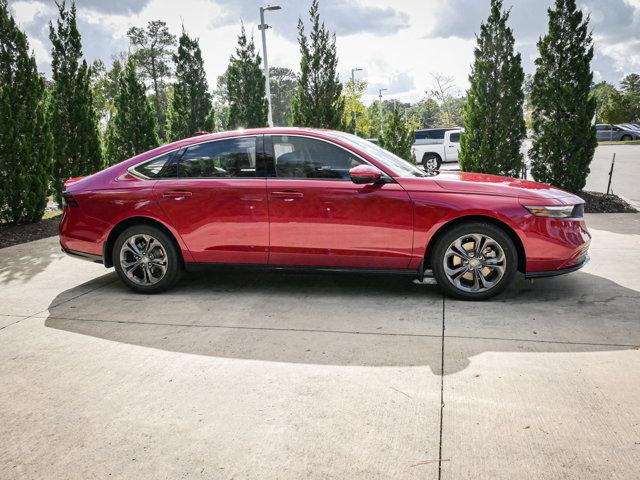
[154,135,269,264]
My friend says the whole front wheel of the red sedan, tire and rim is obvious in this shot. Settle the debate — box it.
[431,222,518,300]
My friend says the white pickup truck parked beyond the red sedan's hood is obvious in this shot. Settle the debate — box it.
[411,128,464,171]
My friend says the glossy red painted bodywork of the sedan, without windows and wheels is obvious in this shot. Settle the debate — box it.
[60,128,590,273]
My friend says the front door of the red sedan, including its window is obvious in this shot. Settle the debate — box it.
[265,135,413,268]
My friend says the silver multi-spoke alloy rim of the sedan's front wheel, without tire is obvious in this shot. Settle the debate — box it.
[443,233,507,293]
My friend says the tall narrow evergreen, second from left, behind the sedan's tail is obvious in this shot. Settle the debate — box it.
[48,1,102,201]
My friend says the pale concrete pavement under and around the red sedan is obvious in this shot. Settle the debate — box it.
[0,215,640,480]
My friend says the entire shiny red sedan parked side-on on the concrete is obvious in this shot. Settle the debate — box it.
[60,128,590,300]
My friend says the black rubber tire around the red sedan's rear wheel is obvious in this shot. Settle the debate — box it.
[113,224,183,293]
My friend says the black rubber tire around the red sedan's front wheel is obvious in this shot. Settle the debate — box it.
[430,222,518,300]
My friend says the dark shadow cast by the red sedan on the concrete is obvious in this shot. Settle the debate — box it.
[45,272,640,374]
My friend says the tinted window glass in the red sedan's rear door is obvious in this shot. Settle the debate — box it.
[178,137,256,178]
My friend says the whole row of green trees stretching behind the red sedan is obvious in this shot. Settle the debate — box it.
[0,0,640,223]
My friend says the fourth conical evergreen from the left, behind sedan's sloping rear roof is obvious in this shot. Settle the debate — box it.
[166,30,212,140]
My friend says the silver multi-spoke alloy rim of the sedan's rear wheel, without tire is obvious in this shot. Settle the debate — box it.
[120,234,169,285]
